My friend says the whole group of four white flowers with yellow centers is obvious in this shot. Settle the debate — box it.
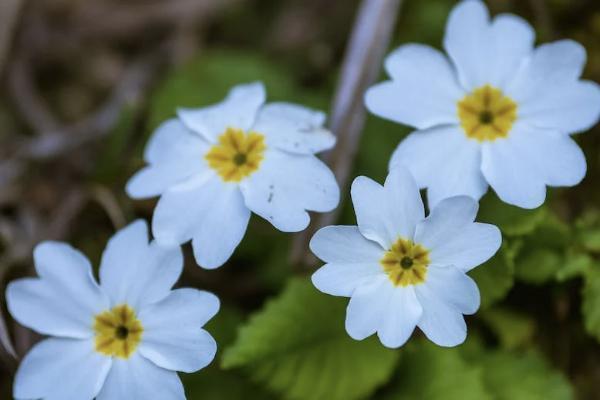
[6,0,600,400]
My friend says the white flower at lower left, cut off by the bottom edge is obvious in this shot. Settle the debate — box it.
[6,221,219,400]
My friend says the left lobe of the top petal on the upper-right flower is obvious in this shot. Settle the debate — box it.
[444,0,490,90]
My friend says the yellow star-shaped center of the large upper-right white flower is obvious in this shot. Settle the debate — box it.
[458,85,517,142]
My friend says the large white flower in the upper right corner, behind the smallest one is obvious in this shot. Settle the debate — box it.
[365,0,600,208]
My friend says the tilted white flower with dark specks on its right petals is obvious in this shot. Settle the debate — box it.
[127,83,339,268]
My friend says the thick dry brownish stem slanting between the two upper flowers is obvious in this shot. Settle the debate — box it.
[292,0,401,267]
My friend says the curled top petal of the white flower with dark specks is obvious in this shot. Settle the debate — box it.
[177,82,266,143]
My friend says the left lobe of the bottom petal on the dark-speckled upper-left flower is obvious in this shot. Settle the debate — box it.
[152,173,229,245]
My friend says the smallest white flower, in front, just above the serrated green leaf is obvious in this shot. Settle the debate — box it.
[310,168,502,348]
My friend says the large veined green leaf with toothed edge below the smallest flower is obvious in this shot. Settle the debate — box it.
[223,279,399,400]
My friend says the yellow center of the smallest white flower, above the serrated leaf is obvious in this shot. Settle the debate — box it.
[380,238,429,287]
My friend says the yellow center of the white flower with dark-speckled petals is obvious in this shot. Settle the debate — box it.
[205,128,267,182]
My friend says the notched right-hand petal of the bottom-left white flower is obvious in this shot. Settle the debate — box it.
[139,289,219,372]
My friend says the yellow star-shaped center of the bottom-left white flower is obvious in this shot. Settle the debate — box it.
[94,304,144,358]
